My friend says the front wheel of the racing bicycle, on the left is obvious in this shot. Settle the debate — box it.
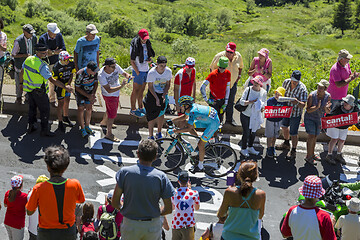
[152,138,185,172]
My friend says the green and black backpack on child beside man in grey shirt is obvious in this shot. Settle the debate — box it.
[99,205,118,240]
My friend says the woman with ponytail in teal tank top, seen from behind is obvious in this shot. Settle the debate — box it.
[217,161,266,240]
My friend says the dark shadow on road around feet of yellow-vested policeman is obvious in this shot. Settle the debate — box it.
[1,115,62,164]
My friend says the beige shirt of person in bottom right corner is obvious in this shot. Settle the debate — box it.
[335,214,360,240]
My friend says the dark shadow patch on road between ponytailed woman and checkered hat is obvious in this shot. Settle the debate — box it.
[259,154,298,189]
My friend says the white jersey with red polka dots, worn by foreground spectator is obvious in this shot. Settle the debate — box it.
[171,187,200,229]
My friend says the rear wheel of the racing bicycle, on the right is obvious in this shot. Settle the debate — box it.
[204,143,237,177]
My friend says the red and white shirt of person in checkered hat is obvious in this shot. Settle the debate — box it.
[281,205,336,240]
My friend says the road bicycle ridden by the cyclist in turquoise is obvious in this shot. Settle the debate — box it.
[152,121,237,177]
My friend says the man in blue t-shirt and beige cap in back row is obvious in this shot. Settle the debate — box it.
[74,24,100,71]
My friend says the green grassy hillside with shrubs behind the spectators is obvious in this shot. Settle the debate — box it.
[0,0,360,96]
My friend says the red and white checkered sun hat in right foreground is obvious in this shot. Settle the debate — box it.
[299,175,325,198]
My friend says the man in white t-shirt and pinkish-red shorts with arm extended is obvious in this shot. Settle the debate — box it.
[98,58,133,142]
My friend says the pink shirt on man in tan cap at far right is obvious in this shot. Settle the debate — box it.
[327,62,351,100]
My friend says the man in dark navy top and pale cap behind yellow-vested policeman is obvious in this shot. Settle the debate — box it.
[39,23,66,107]
